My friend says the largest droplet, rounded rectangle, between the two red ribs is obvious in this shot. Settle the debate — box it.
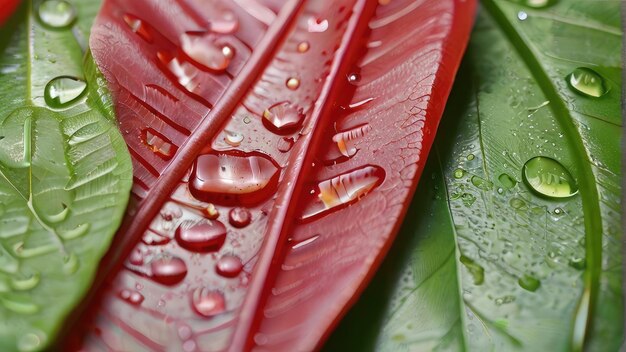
[189,152,280,205]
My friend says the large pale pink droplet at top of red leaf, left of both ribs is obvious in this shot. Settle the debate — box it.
[180,32,230,72]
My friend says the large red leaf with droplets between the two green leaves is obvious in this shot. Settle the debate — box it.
[67,0,475,351]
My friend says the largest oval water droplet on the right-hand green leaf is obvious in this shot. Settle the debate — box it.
[522,156,578,198]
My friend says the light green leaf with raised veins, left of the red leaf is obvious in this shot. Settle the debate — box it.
[0,0,132,351]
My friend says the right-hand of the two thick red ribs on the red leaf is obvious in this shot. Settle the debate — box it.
[229,0,378,352]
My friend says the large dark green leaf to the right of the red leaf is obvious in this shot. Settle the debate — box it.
[327,0,624,351]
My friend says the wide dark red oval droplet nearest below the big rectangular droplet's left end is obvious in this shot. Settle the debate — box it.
[174,220,226,253]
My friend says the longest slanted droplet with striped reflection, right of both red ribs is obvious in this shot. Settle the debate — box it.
[302,166,385,220]
